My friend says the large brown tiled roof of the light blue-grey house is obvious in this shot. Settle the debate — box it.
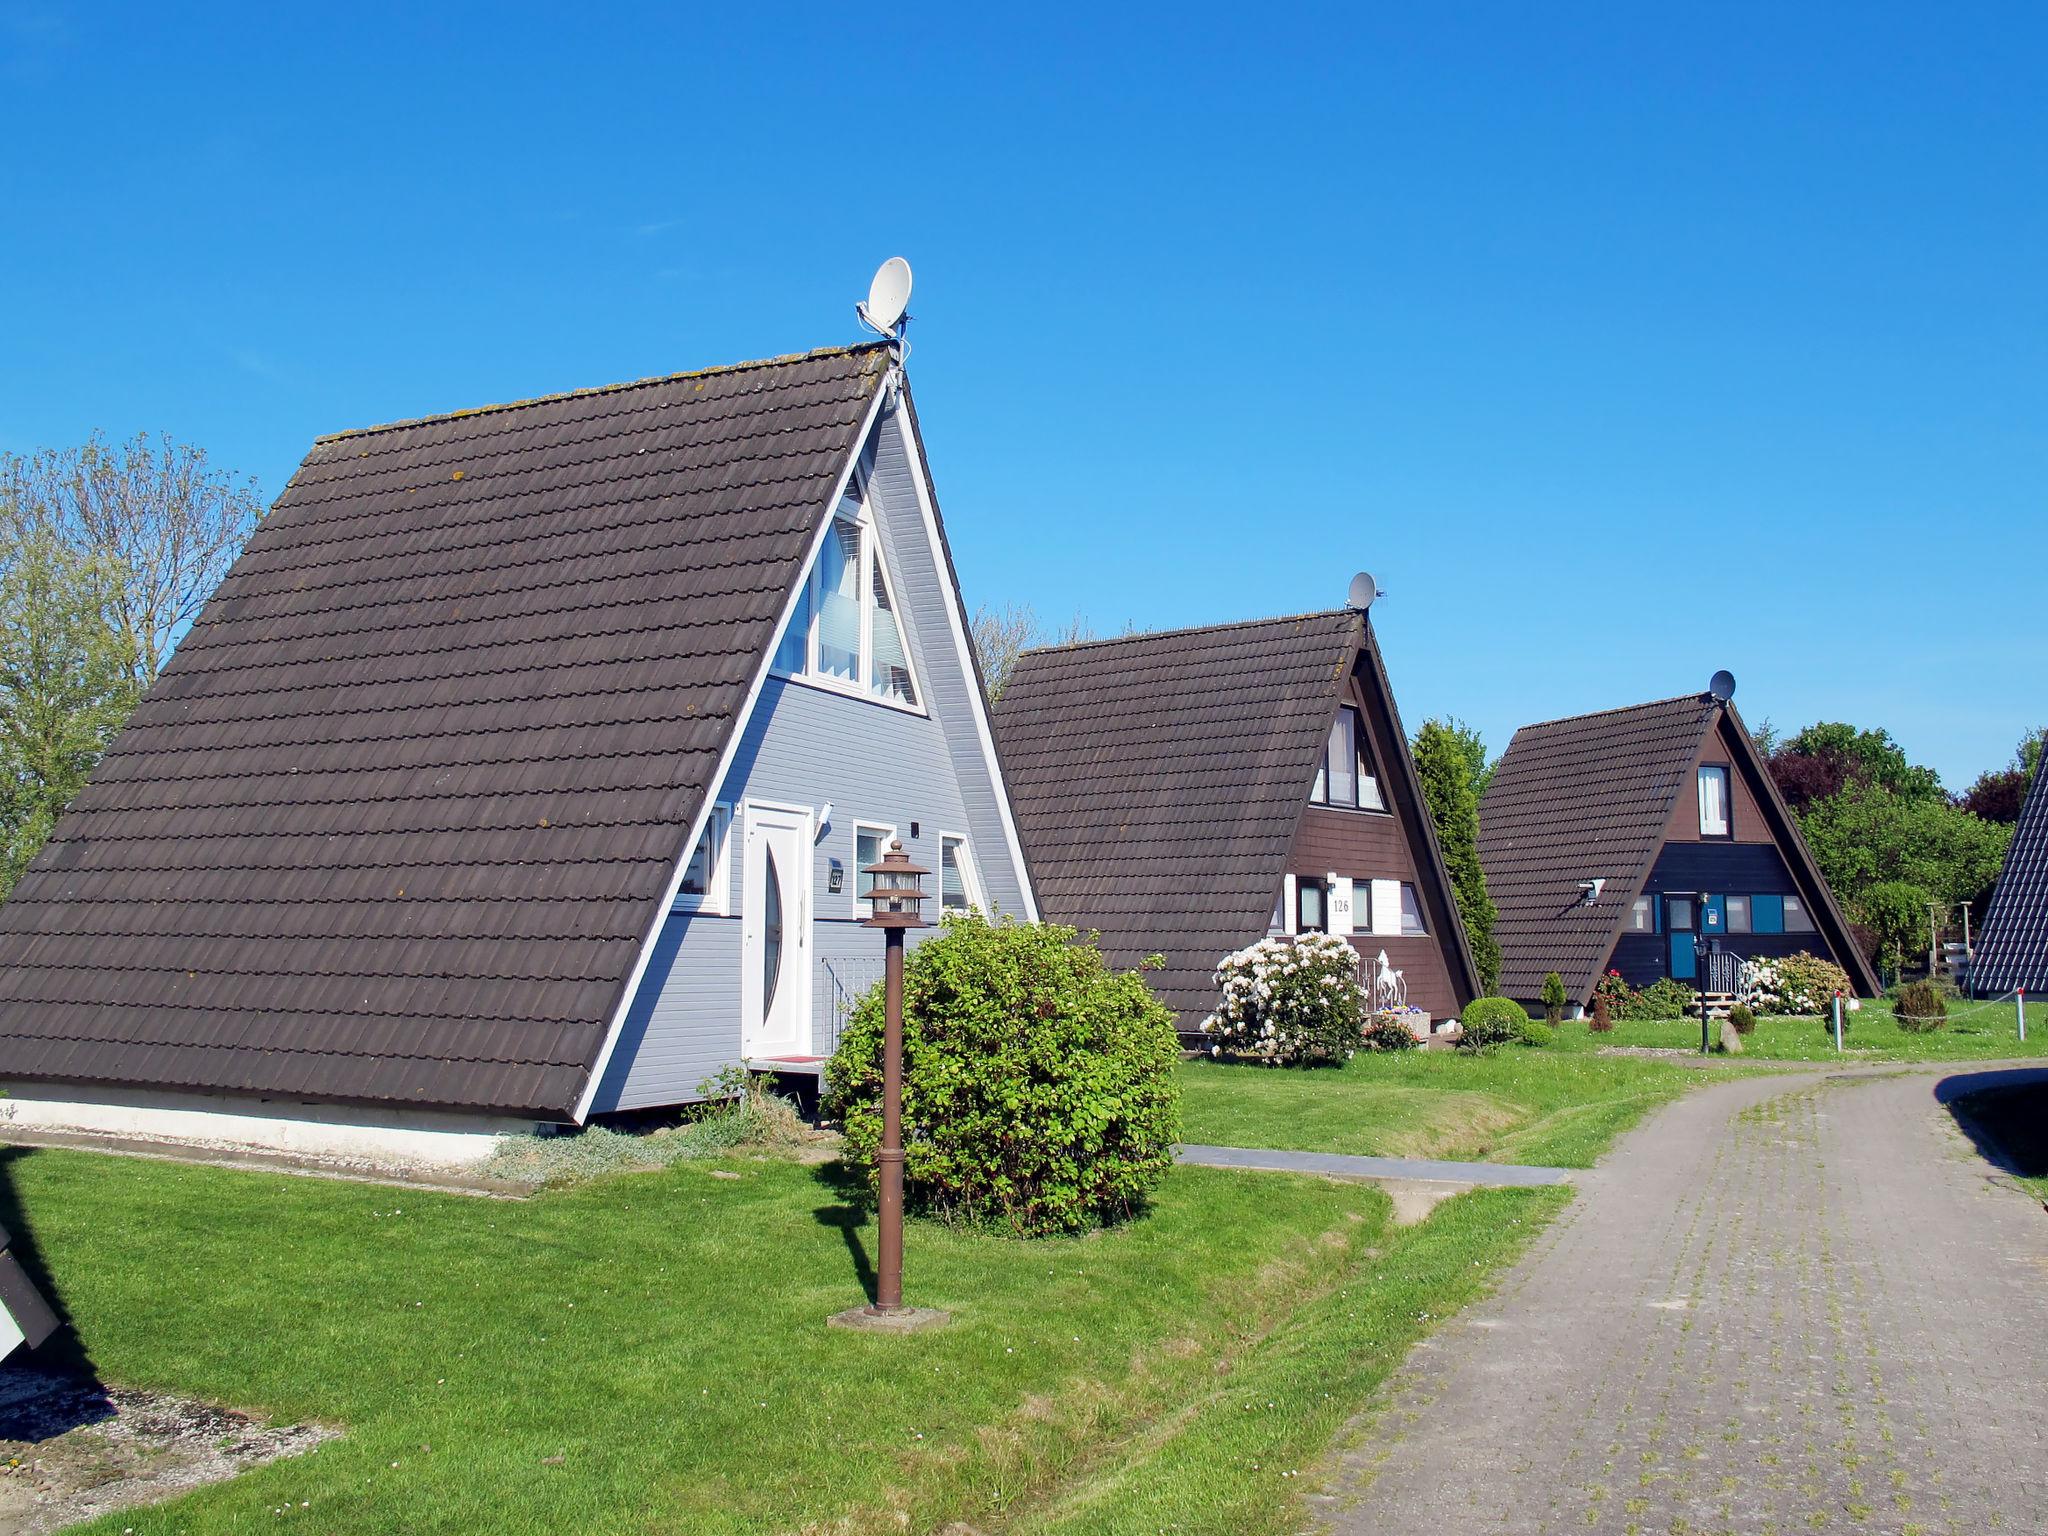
[0,346,887,1116]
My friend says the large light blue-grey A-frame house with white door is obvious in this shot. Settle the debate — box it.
[0,342,1036,1161]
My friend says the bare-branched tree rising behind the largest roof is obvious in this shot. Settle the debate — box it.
[0,432,262,688]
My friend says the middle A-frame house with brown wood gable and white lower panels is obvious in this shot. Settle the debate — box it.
[995,593,1479,1034]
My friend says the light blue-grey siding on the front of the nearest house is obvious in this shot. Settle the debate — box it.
[592,399,1024,1114]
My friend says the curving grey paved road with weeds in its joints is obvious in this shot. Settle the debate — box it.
[1317,1067,2048,1536]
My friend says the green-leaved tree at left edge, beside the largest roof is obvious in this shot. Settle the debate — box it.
[0,528,139,895]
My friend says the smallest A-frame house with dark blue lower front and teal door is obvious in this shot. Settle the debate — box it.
[1479,680,1878,1008]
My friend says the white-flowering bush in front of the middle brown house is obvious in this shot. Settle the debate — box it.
[1202,934,1366,1067]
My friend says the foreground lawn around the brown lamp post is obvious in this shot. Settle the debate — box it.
[0,1146,1548,1536]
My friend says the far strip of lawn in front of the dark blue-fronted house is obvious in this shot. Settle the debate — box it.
[1554,1001,2048,1061]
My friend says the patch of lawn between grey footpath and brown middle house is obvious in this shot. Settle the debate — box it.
[1182,1056,1700,1167]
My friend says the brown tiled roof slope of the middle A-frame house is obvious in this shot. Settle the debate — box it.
[995,612,1364,1026]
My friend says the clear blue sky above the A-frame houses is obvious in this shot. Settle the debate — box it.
[0,0,2048,786]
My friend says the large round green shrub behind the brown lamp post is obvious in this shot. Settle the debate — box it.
[825,915,1180,1237]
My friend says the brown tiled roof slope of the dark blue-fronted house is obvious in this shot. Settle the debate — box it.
[1479,694,1718,999]
